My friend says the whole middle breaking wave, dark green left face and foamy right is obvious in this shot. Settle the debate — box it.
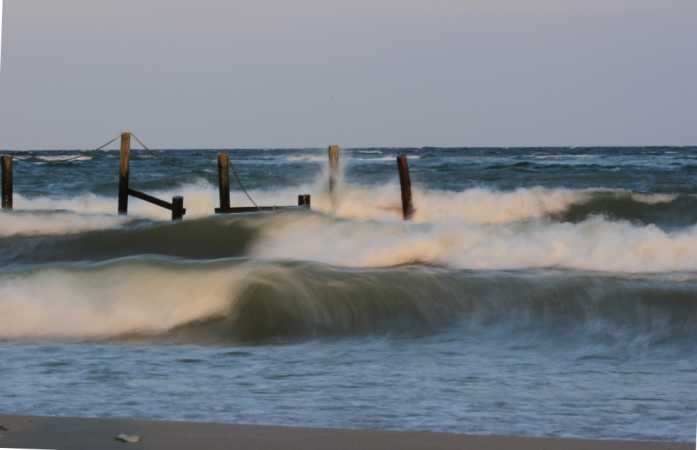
[0,211,697,273]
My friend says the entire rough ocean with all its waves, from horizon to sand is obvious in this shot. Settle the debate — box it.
[0,147,697,441]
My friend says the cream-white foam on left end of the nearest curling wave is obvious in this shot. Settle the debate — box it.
[0,262,246,339]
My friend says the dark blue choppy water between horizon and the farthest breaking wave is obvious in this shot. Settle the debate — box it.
[6,147,697,195]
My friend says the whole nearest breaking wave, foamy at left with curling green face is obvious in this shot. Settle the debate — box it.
[0,259,697,344]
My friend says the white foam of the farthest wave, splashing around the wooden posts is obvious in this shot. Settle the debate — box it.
[6,176,676,230]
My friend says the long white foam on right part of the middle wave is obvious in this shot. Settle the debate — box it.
[253,215,697,273]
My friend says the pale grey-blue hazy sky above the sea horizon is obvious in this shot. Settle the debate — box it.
[0,0,697,150]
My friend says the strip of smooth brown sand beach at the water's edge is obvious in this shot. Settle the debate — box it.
[0,415,692,450]
